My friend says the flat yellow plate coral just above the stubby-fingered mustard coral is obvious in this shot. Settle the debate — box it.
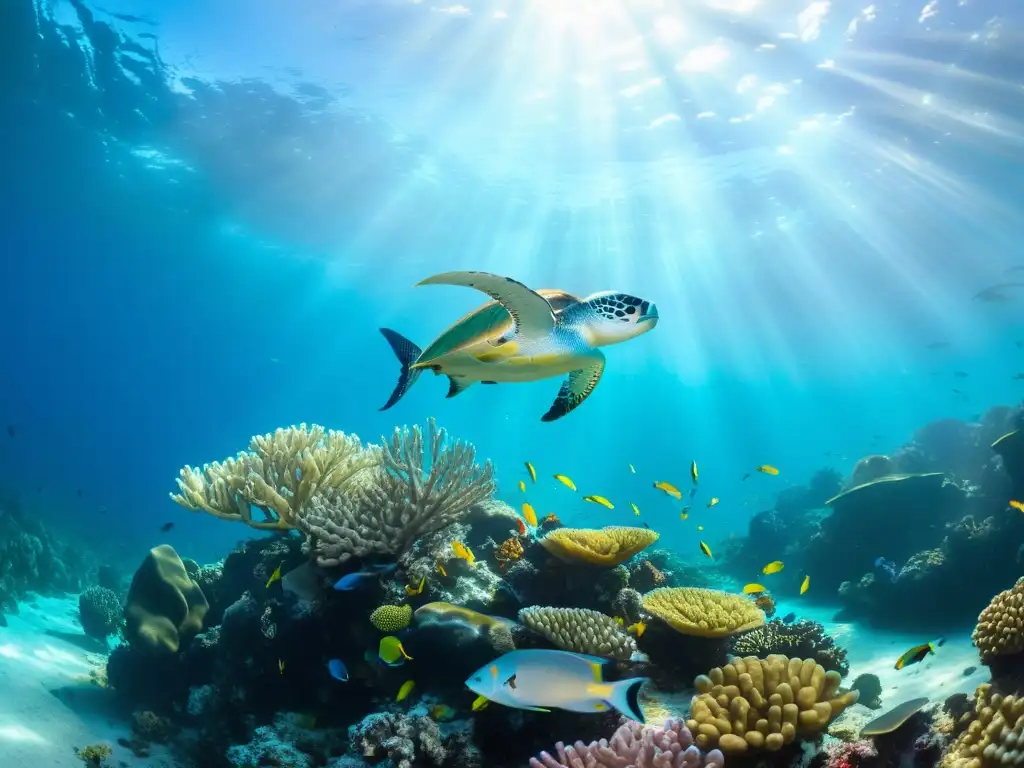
[643,587,765,637]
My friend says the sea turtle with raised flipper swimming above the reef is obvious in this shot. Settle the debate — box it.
[381,271,657,421]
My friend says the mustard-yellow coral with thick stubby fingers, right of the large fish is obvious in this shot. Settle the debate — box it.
[686,655,858,755]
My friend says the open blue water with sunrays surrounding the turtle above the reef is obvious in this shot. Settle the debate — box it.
[0,0,1024,561]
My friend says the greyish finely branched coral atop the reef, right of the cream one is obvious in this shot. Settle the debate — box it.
[295,419,495,566]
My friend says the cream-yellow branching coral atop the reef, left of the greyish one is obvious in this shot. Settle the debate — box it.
[170,424,380,529]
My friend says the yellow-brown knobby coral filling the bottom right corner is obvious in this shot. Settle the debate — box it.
[941,683,1024,768]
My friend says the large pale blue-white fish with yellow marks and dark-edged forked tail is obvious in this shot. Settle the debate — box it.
[466,649,647,723]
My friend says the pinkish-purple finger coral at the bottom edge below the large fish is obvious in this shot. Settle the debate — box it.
[529,720,725,768]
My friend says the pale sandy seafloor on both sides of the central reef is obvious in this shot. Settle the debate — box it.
[0,597,988,768]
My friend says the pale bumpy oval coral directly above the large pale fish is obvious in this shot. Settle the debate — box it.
[519,606,637,662]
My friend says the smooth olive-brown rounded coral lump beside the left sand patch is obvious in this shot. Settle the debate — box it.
[125,544,209,653]
